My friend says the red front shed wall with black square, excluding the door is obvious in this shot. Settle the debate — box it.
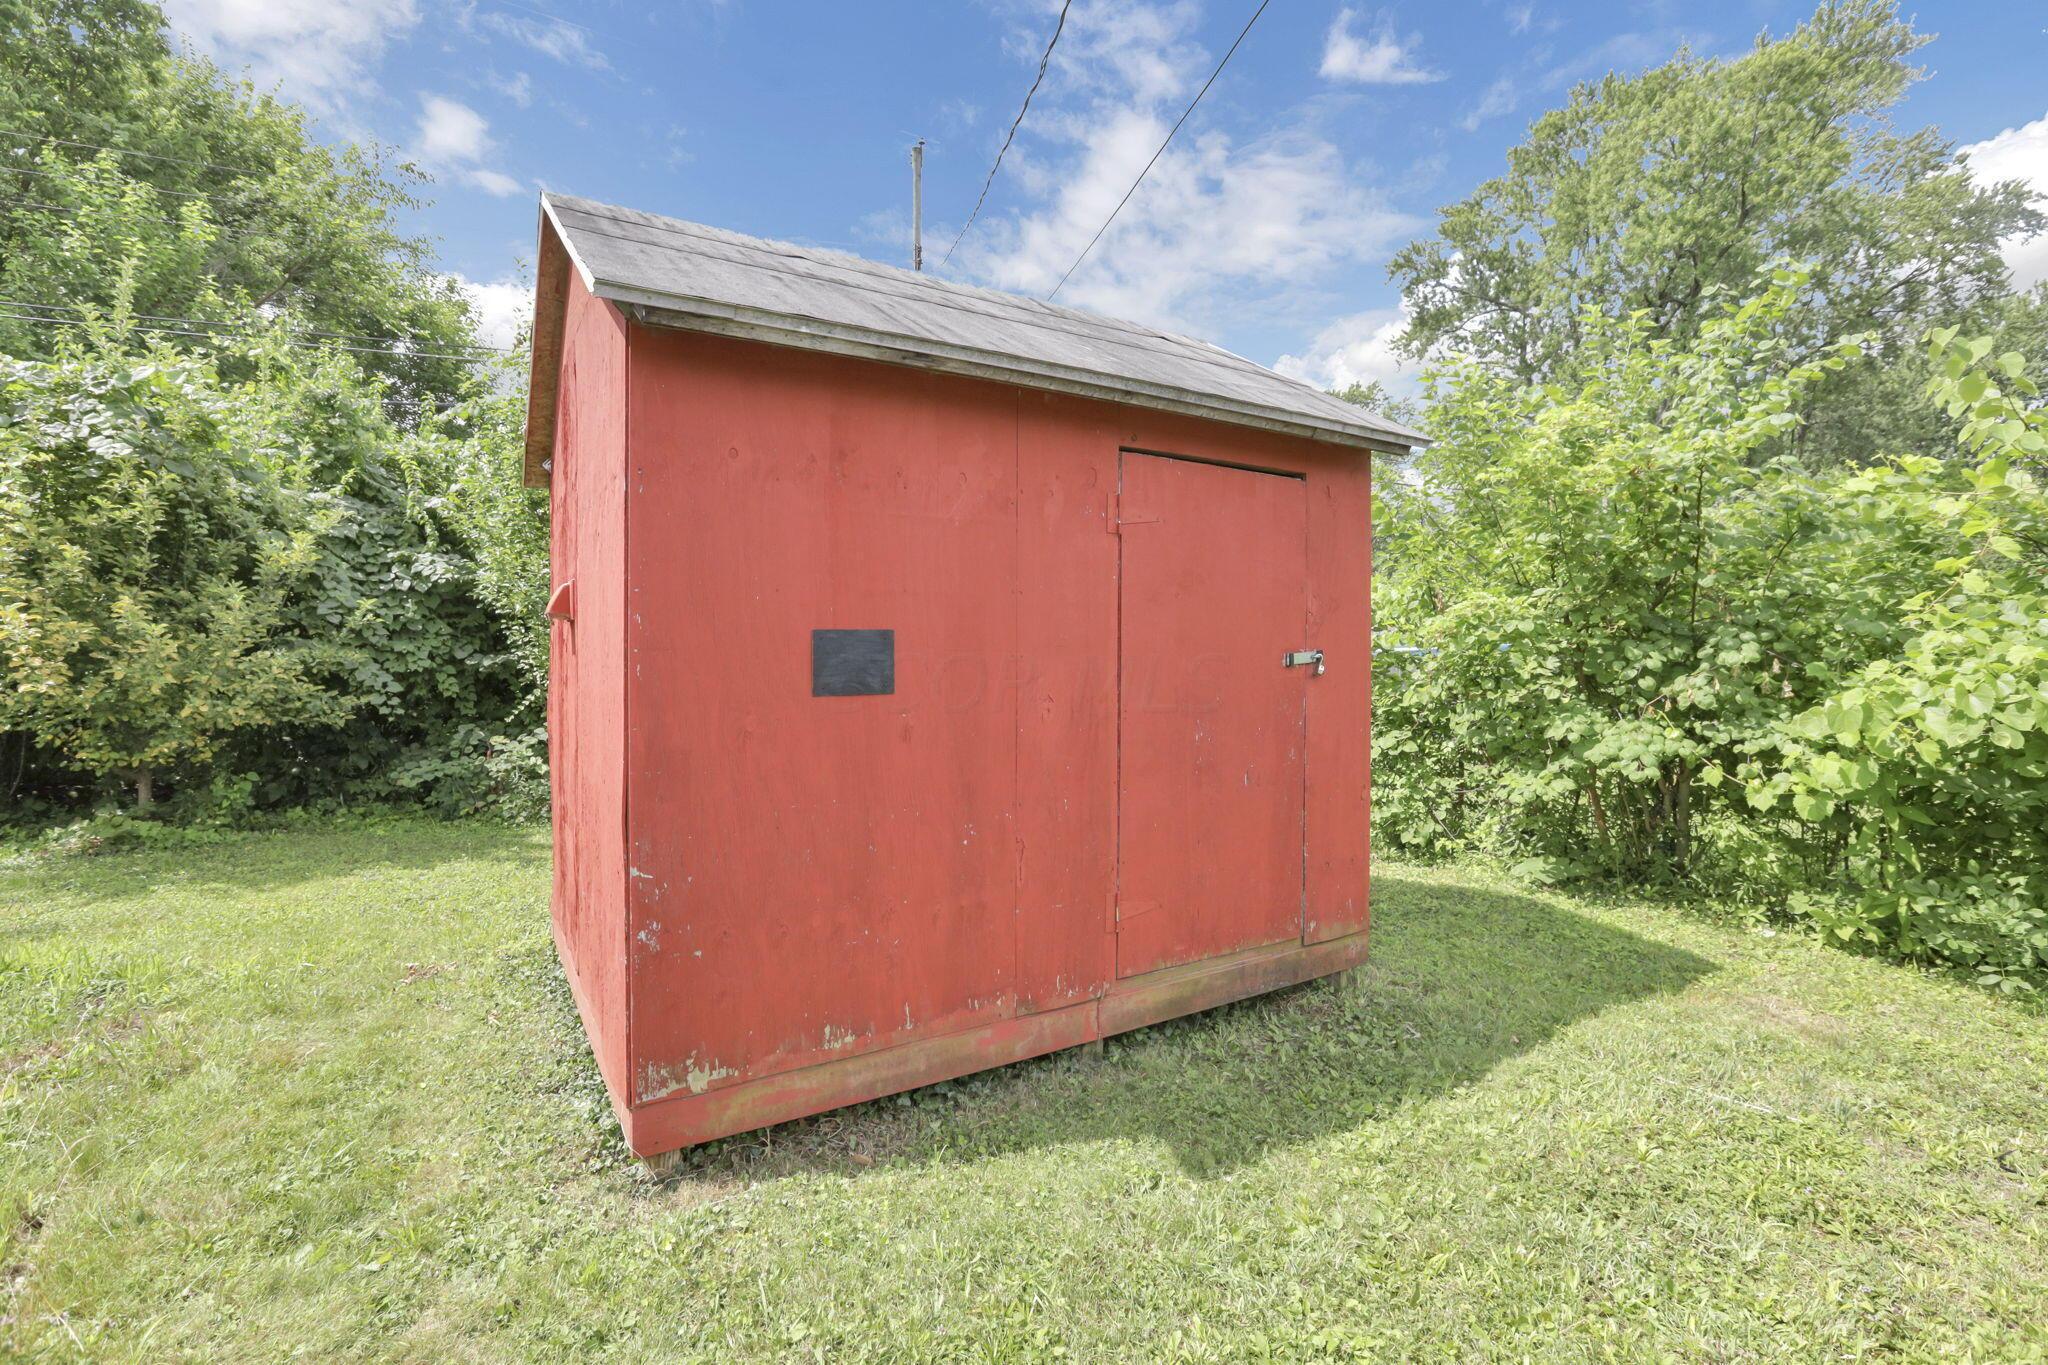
[614,325,1370,1144]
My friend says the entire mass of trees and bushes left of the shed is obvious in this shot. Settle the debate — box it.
[0,0,545,810]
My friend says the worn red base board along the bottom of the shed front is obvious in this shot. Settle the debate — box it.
[569,933,1366,1156]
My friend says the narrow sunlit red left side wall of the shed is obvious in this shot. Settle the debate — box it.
[547,278,629,1103]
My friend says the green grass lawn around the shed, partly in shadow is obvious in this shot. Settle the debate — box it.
[0,825,2048,1361]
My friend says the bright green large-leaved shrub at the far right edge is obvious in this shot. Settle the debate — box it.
[1747,332,2048,986]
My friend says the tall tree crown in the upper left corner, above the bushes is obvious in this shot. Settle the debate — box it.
[0,0,475,420]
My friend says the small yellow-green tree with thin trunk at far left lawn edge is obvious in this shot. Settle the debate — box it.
[0,354,348,808]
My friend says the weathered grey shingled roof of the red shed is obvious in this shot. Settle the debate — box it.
[526,194,1425,479]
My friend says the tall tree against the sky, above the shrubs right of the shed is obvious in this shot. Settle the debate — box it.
[1391,0,2044,458]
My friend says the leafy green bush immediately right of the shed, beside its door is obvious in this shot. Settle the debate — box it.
[1374,272,1954,878]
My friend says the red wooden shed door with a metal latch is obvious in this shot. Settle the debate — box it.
[1116,450,1315,976]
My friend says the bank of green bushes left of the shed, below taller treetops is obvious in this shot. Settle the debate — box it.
[0,336,545,821]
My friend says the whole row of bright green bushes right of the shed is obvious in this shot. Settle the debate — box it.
[1374,294,2048,988]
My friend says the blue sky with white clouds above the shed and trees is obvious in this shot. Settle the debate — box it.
[166,0,2048,385]
